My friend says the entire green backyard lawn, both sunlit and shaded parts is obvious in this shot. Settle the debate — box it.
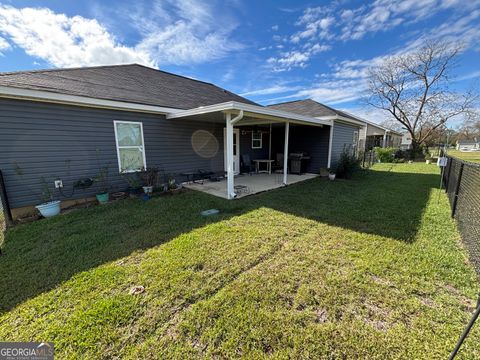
[0,163,480,359]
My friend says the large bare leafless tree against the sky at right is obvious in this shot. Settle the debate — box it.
[367,41,476,150]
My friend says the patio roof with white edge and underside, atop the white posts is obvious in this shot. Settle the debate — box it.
[167,101,332,126]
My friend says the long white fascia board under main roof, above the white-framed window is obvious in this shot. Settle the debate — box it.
[0,86,180,114]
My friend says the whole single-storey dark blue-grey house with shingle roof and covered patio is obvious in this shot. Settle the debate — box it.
[0,64,364,217]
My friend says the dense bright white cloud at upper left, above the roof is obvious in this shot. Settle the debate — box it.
[0,6,154,66]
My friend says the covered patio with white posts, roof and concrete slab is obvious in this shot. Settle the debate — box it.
[167,101,332,199]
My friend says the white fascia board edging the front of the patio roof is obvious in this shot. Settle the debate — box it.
[167,101,332,125]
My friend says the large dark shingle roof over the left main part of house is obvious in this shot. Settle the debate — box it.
[0,64,257,109]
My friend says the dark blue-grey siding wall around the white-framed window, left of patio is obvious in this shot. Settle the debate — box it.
[0,99,223,209]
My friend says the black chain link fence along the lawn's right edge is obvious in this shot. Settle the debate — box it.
[443,156,480,276]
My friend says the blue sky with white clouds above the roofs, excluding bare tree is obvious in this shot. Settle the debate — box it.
[0,0,480,121]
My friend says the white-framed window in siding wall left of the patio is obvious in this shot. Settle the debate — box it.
[113,121,147,173]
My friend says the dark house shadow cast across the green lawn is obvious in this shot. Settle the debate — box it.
[0,165,438,314]
